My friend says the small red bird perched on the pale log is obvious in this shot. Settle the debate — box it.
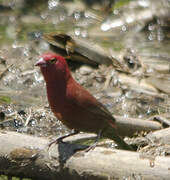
[36,53,132,150]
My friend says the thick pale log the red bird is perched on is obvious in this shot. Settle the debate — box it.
[0,131,170,180]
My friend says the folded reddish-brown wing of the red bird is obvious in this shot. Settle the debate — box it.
[67,83,115,122]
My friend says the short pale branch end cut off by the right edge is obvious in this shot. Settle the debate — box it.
[147,128,170,144]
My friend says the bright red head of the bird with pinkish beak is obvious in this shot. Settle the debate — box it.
[35,53,70,80]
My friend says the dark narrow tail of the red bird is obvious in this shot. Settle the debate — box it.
[103,128,134,151]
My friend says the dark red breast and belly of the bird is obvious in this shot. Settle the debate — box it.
[47,85,106,133]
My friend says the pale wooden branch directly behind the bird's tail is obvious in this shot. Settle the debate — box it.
[114,116,162,137]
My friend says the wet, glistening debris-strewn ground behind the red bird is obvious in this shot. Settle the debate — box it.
[0,0,170,158]
